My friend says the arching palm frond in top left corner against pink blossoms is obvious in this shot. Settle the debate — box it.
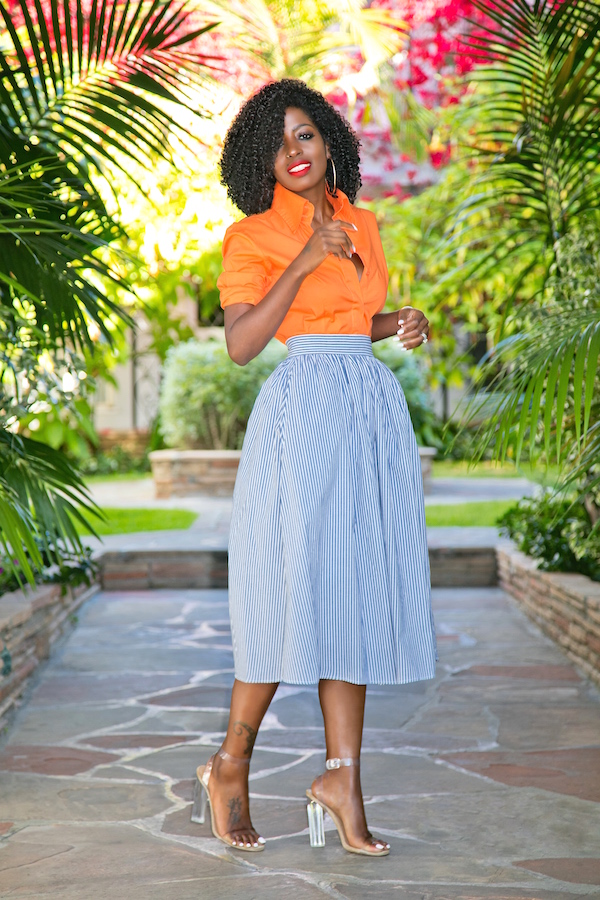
[0,0,215,171]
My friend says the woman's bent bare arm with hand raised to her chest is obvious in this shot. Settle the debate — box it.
[225,220,354,366]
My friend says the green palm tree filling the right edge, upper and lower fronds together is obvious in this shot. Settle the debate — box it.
[448,0,600,519]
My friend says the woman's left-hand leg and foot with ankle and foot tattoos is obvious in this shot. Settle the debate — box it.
[205,680,277,844]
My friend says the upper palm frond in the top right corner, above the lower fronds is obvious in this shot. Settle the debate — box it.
[446,0,600,312]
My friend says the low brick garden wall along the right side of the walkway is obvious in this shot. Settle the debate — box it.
[497,545,600,684]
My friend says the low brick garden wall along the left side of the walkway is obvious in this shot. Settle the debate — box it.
[0,584,98,728]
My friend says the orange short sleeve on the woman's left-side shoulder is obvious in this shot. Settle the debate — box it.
[217,223,269,308]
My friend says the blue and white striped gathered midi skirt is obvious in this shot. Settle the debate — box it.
[229,335,436,684]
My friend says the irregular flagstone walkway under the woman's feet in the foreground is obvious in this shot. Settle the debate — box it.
[0,589,600,900]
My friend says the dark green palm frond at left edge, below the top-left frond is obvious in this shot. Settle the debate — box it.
[0,126,130,347]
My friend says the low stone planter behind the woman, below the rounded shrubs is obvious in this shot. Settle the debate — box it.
[148,447,437,499]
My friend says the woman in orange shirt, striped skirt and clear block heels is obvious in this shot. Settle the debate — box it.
[192,80,436,856]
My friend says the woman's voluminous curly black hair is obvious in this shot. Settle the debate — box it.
[219,78,361,216]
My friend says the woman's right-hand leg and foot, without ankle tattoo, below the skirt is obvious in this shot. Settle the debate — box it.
[312,680,387,850]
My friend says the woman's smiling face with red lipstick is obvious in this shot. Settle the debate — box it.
[273,106,329,194]
